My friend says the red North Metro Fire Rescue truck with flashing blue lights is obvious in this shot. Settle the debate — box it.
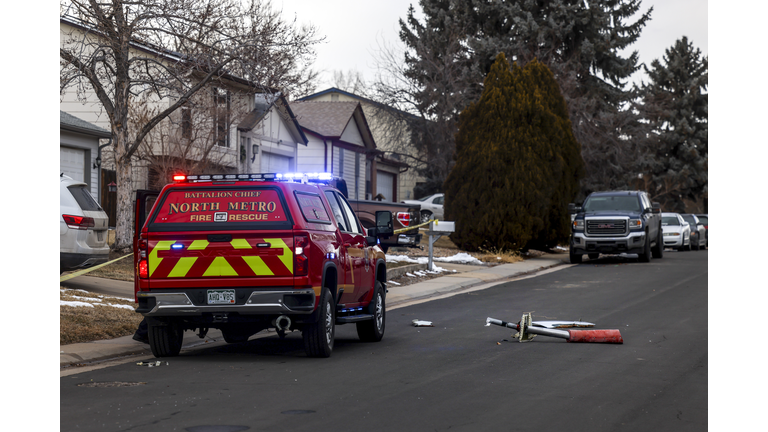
[134,173,393,357]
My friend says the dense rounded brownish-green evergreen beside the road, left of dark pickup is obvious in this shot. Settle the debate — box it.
[444,53,583,250]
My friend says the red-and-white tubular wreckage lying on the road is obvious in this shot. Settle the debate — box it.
[485,313,624,344]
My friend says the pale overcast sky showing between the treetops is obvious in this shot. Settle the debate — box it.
[273,0,708,90]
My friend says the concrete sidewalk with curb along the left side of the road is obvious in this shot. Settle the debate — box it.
[60,254,569,368]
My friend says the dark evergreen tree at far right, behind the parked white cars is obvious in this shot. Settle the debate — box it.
[641,36,709,213]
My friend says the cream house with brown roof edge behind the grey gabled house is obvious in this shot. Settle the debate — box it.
[298,87,424,201]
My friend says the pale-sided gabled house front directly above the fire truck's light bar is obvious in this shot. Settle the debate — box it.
[237,94,308,173]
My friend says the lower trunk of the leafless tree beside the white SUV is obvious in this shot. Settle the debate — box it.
[112,130,133,254]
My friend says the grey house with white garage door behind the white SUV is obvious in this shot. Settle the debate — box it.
[59,111,112,203]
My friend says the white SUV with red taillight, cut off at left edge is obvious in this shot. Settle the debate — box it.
[59,174,109,272]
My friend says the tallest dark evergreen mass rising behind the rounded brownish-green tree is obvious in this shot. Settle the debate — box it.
[400,0,652,193]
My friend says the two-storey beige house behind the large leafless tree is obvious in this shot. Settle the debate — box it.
[59,16,276,196]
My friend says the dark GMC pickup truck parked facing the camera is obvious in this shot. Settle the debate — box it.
[568,191,664,264]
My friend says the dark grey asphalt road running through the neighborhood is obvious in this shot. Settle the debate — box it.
[60,251,708,432]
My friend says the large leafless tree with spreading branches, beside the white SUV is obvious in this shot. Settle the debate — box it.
[60,0,320,252]
